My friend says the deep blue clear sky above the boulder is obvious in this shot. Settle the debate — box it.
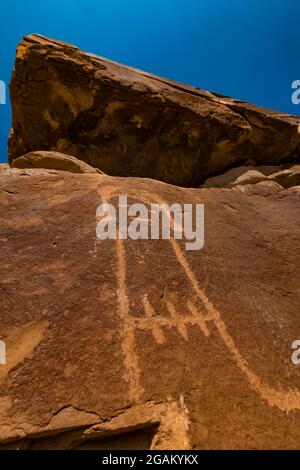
[0,0,300,161]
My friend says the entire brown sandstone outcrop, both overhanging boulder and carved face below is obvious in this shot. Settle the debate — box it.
[0,35,300,449]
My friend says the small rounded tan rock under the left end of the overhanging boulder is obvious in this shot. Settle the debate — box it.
[11,151,102,173]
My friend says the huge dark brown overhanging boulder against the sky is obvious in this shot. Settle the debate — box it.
[9,35,300,186]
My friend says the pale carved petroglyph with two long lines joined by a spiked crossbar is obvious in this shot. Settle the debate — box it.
[99,186,300,412]
